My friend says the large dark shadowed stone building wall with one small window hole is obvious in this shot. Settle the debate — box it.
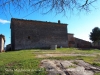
[11,18,68,50]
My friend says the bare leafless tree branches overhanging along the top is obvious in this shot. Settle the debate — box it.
[0,0,97,15]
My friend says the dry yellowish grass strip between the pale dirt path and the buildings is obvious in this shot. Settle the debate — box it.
[31,48,100,54]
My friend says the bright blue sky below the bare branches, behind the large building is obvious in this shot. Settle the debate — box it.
[0,0,100,46]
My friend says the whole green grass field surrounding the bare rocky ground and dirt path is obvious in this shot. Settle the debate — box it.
[0,48,100,75]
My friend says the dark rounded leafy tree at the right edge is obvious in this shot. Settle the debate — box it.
[90,27,100,42]
